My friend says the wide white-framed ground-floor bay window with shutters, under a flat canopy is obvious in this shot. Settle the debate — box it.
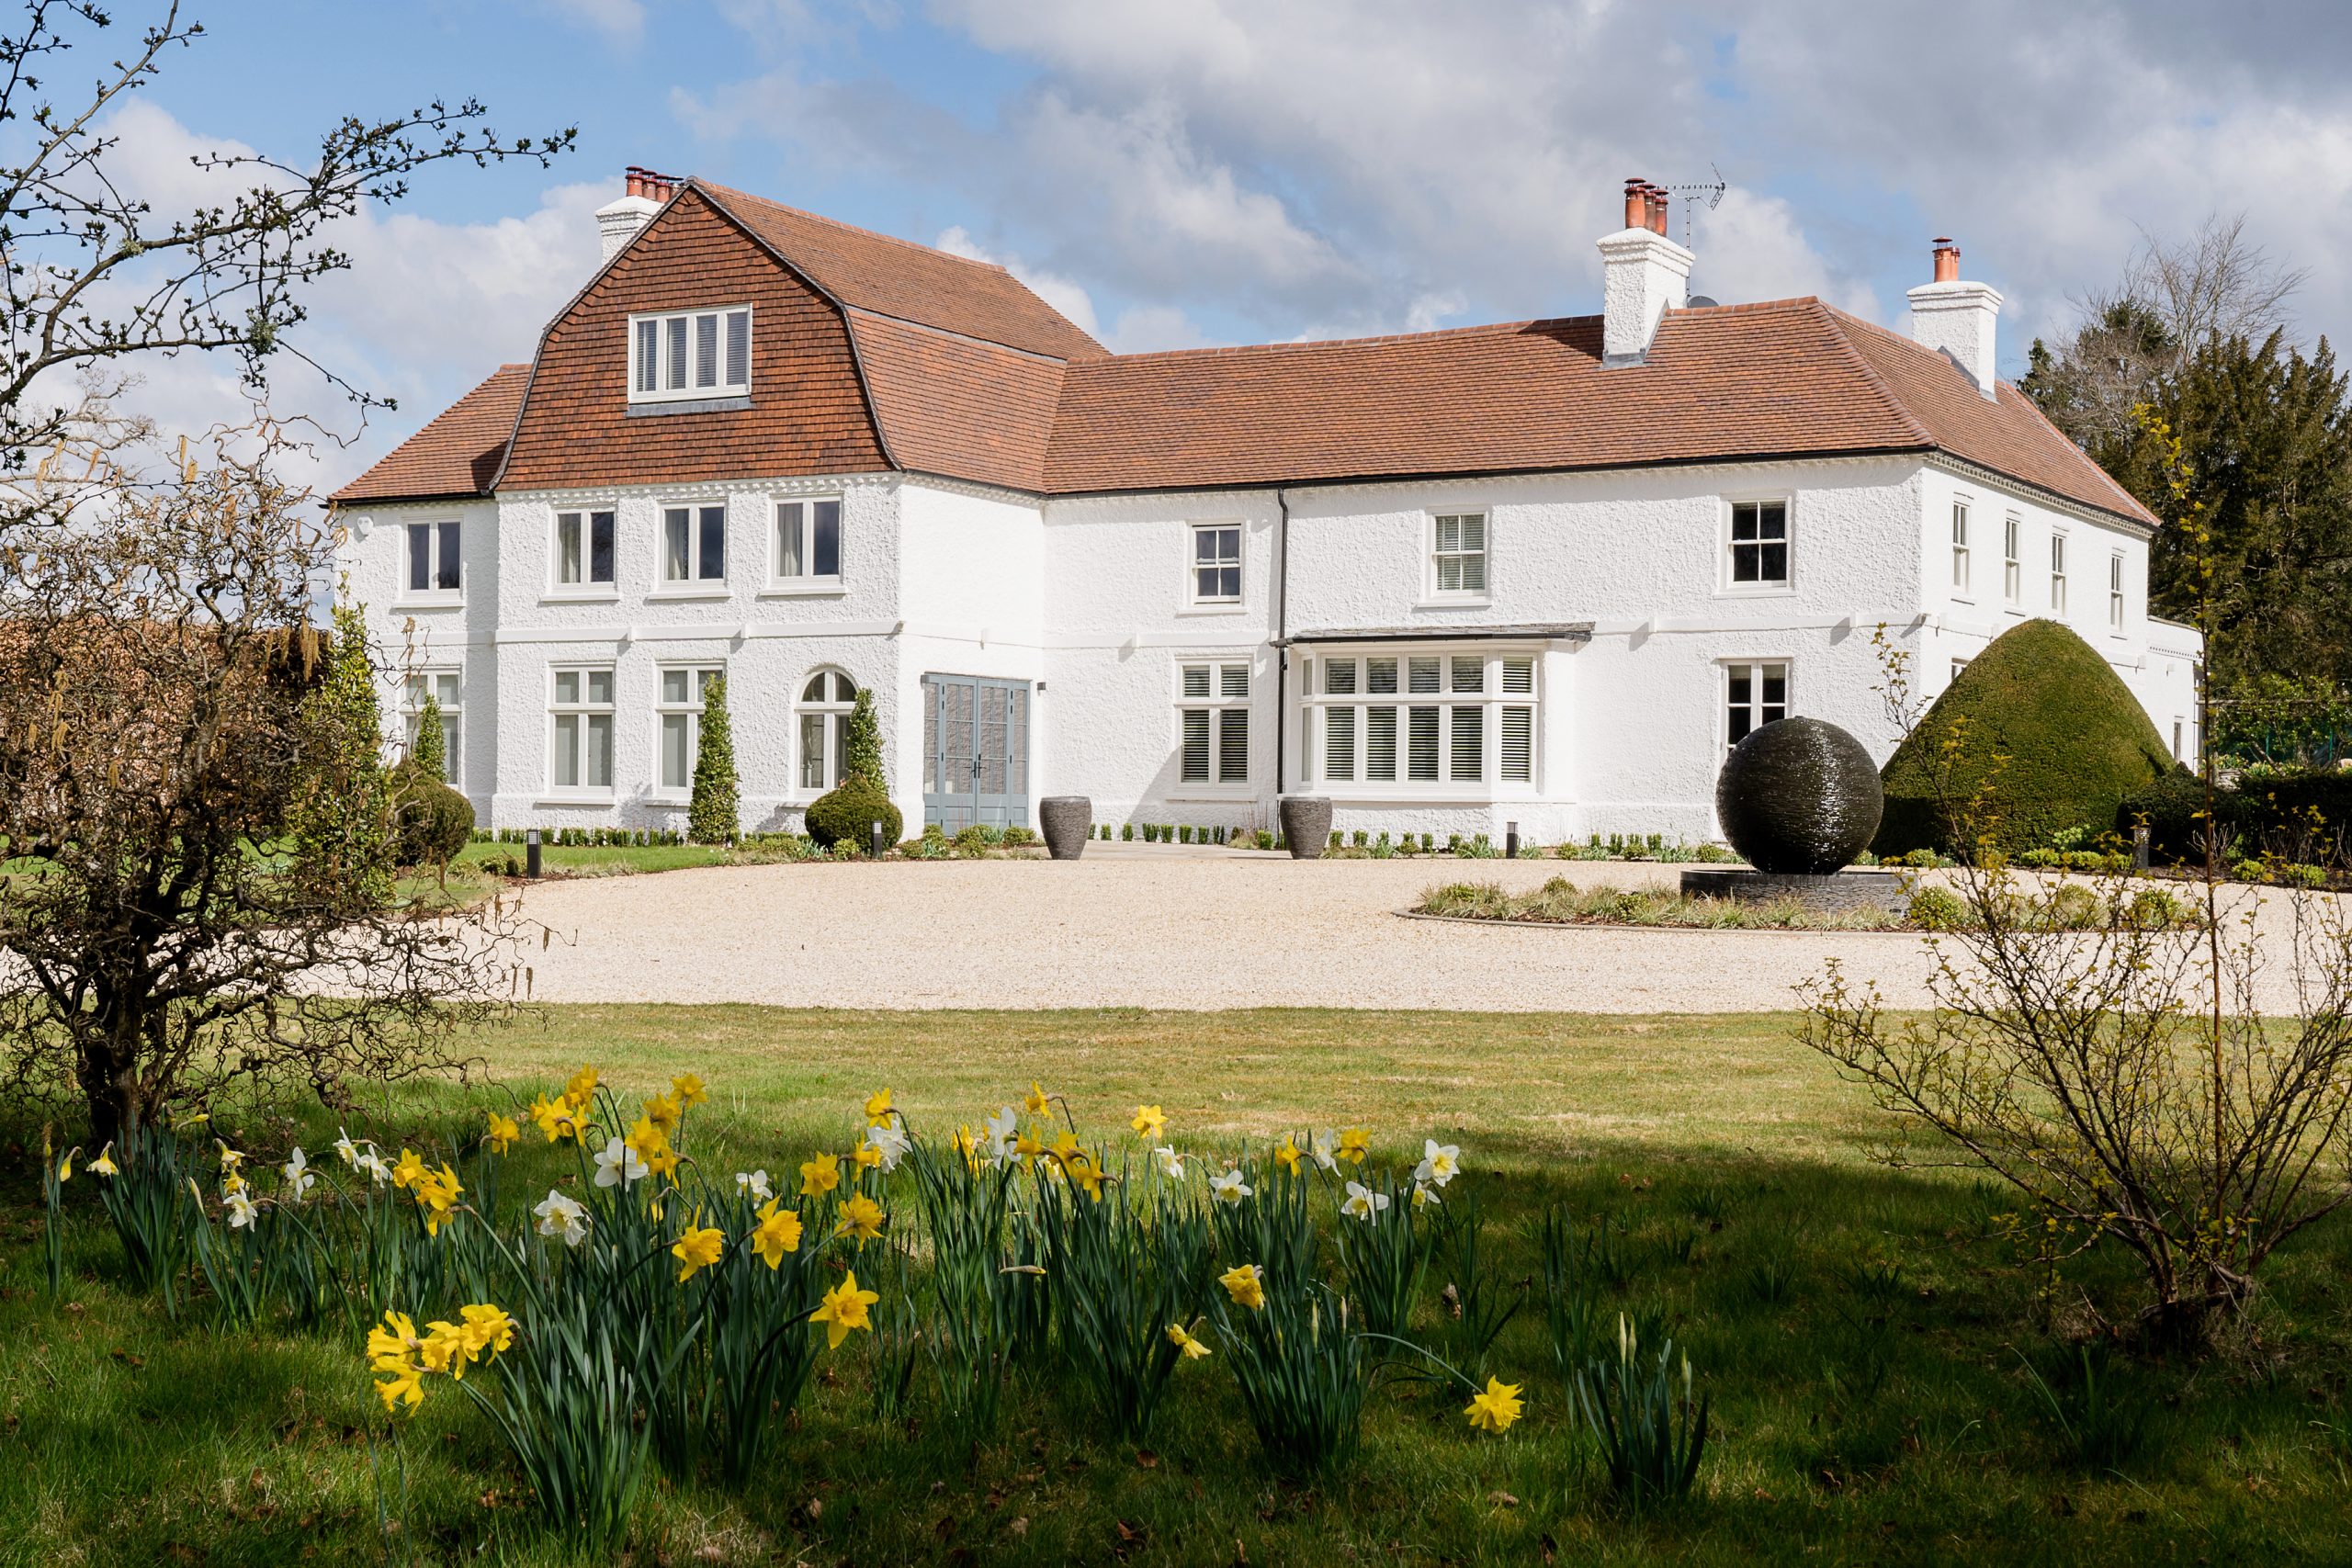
[1298,642,1543,802]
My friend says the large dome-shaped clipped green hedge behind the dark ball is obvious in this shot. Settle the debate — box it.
[1874,621,2173,858]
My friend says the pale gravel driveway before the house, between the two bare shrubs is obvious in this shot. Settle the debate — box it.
[501,846,1928,1013]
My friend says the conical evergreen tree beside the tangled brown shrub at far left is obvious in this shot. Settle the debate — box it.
[287,604,395,903]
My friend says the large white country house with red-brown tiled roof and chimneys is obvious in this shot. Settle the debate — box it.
[334,169,2201,841]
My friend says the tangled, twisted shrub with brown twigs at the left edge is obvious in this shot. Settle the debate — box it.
[0,415,513,1138]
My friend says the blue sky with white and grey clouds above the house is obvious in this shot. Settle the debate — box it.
[114,0,2352,482]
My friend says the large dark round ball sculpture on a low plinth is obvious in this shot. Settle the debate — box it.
[1714,719,1886,877]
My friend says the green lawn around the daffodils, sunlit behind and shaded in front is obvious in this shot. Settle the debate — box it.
[0,1006,2352,1565]
